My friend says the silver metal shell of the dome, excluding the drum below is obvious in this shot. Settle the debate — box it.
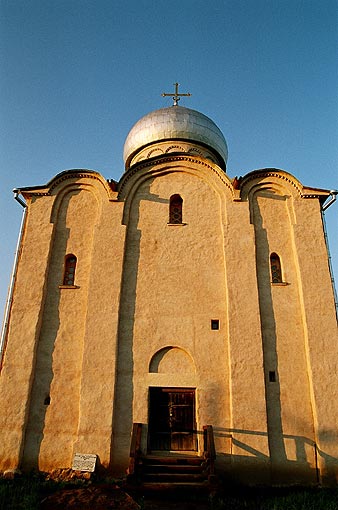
[123,106,228,168]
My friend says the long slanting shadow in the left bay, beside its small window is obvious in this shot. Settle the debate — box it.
[22,190,80,470]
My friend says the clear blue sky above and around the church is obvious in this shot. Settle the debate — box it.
[0,0,338,309]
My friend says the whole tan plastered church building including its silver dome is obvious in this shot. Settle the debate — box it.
[0,105,338,484]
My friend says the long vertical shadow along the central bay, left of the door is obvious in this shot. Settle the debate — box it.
[111,178,169,472]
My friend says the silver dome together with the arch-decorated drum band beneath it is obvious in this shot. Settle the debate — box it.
[123,105,228,170]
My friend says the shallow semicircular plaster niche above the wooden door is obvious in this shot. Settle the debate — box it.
[149,346,196,374]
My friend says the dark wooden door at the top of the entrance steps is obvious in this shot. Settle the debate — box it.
[149,388,196,451]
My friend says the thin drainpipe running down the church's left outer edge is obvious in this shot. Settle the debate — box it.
[0,189,27,370]
